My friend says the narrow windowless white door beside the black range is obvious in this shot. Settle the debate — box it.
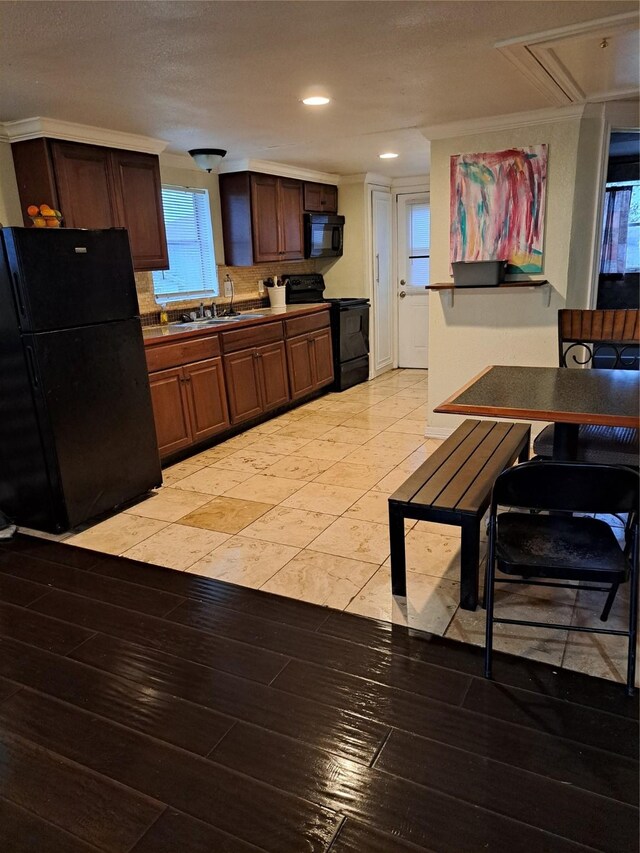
[371,190,395,374]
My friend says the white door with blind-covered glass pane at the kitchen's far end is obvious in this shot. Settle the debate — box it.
[397,193,431,368]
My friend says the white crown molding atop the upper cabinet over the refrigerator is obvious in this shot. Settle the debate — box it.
[1,116,167,154]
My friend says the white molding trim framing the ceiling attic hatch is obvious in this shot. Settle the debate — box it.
[495,12,640,105]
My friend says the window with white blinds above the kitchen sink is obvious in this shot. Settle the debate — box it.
[153,186,218,302]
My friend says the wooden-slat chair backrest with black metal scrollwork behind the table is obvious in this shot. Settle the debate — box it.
[558,308,640,370]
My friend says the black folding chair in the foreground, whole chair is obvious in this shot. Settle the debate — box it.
[484,460,640,695]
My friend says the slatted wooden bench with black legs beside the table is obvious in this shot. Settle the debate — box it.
[389,420,531,610]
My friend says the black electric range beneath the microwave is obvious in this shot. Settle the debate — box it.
[283,273,369,391]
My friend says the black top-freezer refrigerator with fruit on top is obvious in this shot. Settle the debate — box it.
[0,228,162,533]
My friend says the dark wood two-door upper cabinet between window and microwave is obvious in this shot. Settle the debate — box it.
[220,172,304,266]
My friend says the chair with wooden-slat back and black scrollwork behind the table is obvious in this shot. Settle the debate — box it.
[533,309,640,468]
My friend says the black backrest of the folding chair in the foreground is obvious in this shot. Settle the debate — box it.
[492,460,640,514]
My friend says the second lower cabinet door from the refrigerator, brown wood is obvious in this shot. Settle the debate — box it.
[182,358,230,441]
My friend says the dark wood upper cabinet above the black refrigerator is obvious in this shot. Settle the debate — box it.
[11,139,169,270]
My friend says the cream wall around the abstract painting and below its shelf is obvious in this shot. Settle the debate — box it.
[428,109,603,435]
